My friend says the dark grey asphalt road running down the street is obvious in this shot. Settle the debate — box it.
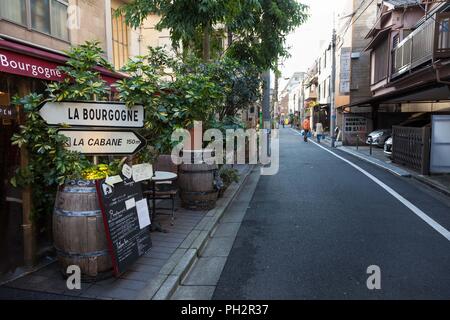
[214,129,450,299]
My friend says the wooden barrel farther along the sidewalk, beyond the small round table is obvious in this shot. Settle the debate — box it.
[178,164,219,210]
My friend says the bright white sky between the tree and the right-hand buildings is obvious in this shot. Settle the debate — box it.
[280,0,344,88]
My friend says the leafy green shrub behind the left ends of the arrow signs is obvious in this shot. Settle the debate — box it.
[11,42,110,221]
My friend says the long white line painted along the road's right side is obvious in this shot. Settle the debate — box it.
[291,129,450,241]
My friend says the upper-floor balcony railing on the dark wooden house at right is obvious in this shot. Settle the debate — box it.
[392,13,450,78]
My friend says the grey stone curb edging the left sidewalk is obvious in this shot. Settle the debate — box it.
[137,165,255,300]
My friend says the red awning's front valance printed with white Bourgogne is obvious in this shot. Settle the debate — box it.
[0,49,64,81]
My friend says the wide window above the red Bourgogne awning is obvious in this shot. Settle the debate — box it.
[0,0,69,40]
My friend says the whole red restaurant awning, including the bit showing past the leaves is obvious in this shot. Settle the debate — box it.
[0,37,125,86]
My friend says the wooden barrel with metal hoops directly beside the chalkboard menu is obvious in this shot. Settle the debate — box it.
[53,180,112,282]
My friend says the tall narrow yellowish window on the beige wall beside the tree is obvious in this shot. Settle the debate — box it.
[112,10,128,69]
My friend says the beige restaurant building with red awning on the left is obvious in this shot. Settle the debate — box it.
[0,0,144,274]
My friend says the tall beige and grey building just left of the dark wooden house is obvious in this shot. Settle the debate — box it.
[335,0,378,145]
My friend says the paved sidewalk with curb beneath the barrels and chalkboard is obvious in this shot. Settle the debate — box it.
[0,166,252,300]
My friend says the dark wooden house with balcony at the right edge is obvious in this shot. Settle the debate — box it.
[367,0,450,174]
